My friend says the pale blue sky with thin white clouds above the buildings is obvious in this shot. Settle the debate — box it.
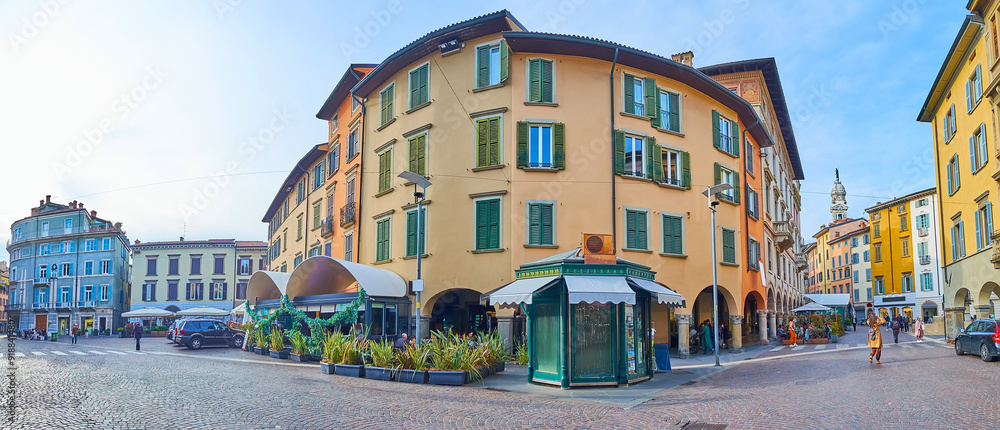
[0,0,968,260]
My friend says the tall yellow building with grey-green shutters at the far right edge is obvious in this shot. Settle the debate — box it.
[920,6,1000,337]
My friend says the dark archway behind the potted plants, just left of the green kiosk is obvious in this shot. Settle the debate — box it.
[421,288,497,334]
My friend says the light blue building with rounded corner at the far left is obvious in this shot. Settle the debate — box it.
[5,196,131,334]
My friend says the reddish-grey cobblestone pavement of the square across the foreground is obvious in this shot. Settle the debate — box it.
[0,335,1000,429]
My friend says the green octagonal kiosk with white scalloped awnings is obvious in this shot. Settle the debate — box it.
[486,248,684,388]
